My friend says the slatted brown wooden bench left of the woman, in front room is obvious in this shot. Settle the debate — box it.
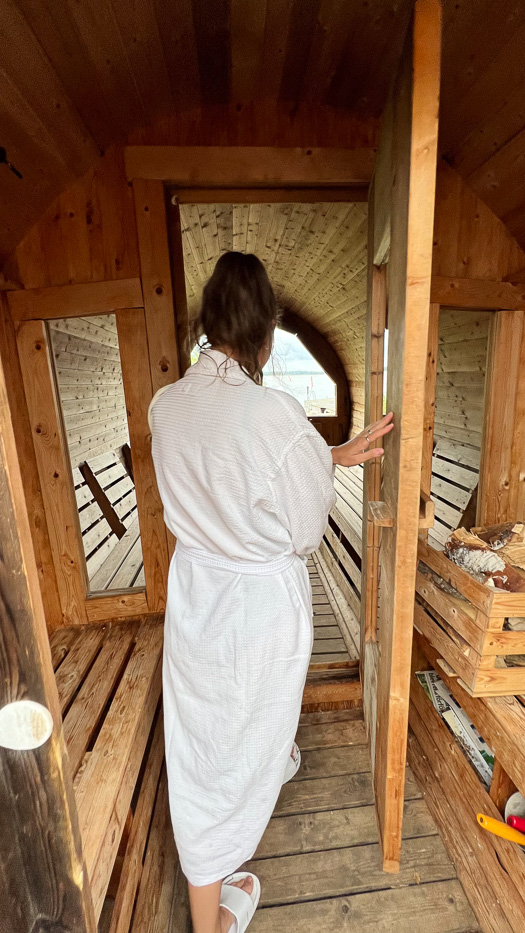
[50,616,164,930]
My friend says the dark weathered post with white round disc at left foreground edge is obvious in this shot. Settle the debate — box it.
[0,334,96,933]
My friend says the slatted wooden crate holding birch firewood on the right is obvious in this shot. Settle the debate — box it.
[414,541,525,696]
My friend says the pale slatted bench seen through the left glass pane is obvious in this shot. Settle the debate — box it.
[73,451,144,592]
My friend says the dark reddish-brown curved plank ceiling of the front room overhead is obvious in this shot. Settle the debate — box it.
[0,0,525,259]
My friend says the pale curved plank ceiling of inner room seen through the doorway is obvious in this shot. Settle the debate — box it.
[180,203,367,420]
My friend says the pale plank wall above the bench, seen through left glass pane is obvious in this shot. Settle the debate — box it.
[49,314,129,468]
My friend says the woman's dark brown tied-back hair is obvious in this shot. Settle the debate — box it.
[190,252,278,382]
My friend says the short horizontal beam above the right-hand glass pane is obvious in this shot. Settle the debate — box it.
[430,275,525,311]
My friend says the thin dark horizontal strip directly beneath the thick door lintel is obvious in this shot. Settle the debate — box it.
[171,185,368,204]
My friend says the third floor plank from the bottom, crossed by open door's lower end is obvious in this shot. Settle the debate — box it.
[255,798,437,859]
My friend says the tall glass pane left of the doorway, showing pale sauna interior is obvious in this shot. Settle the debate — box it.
[48,314,144,594]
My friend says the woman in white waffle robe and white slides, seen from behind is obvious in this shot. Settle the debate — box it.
[150,252,392,933]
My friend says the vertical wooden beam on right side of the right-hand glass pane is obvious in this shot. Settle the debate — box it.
[476,311,525,525]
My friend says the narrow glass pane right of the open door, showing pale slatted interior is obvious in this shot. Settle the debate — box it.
[428,308,494,548]
